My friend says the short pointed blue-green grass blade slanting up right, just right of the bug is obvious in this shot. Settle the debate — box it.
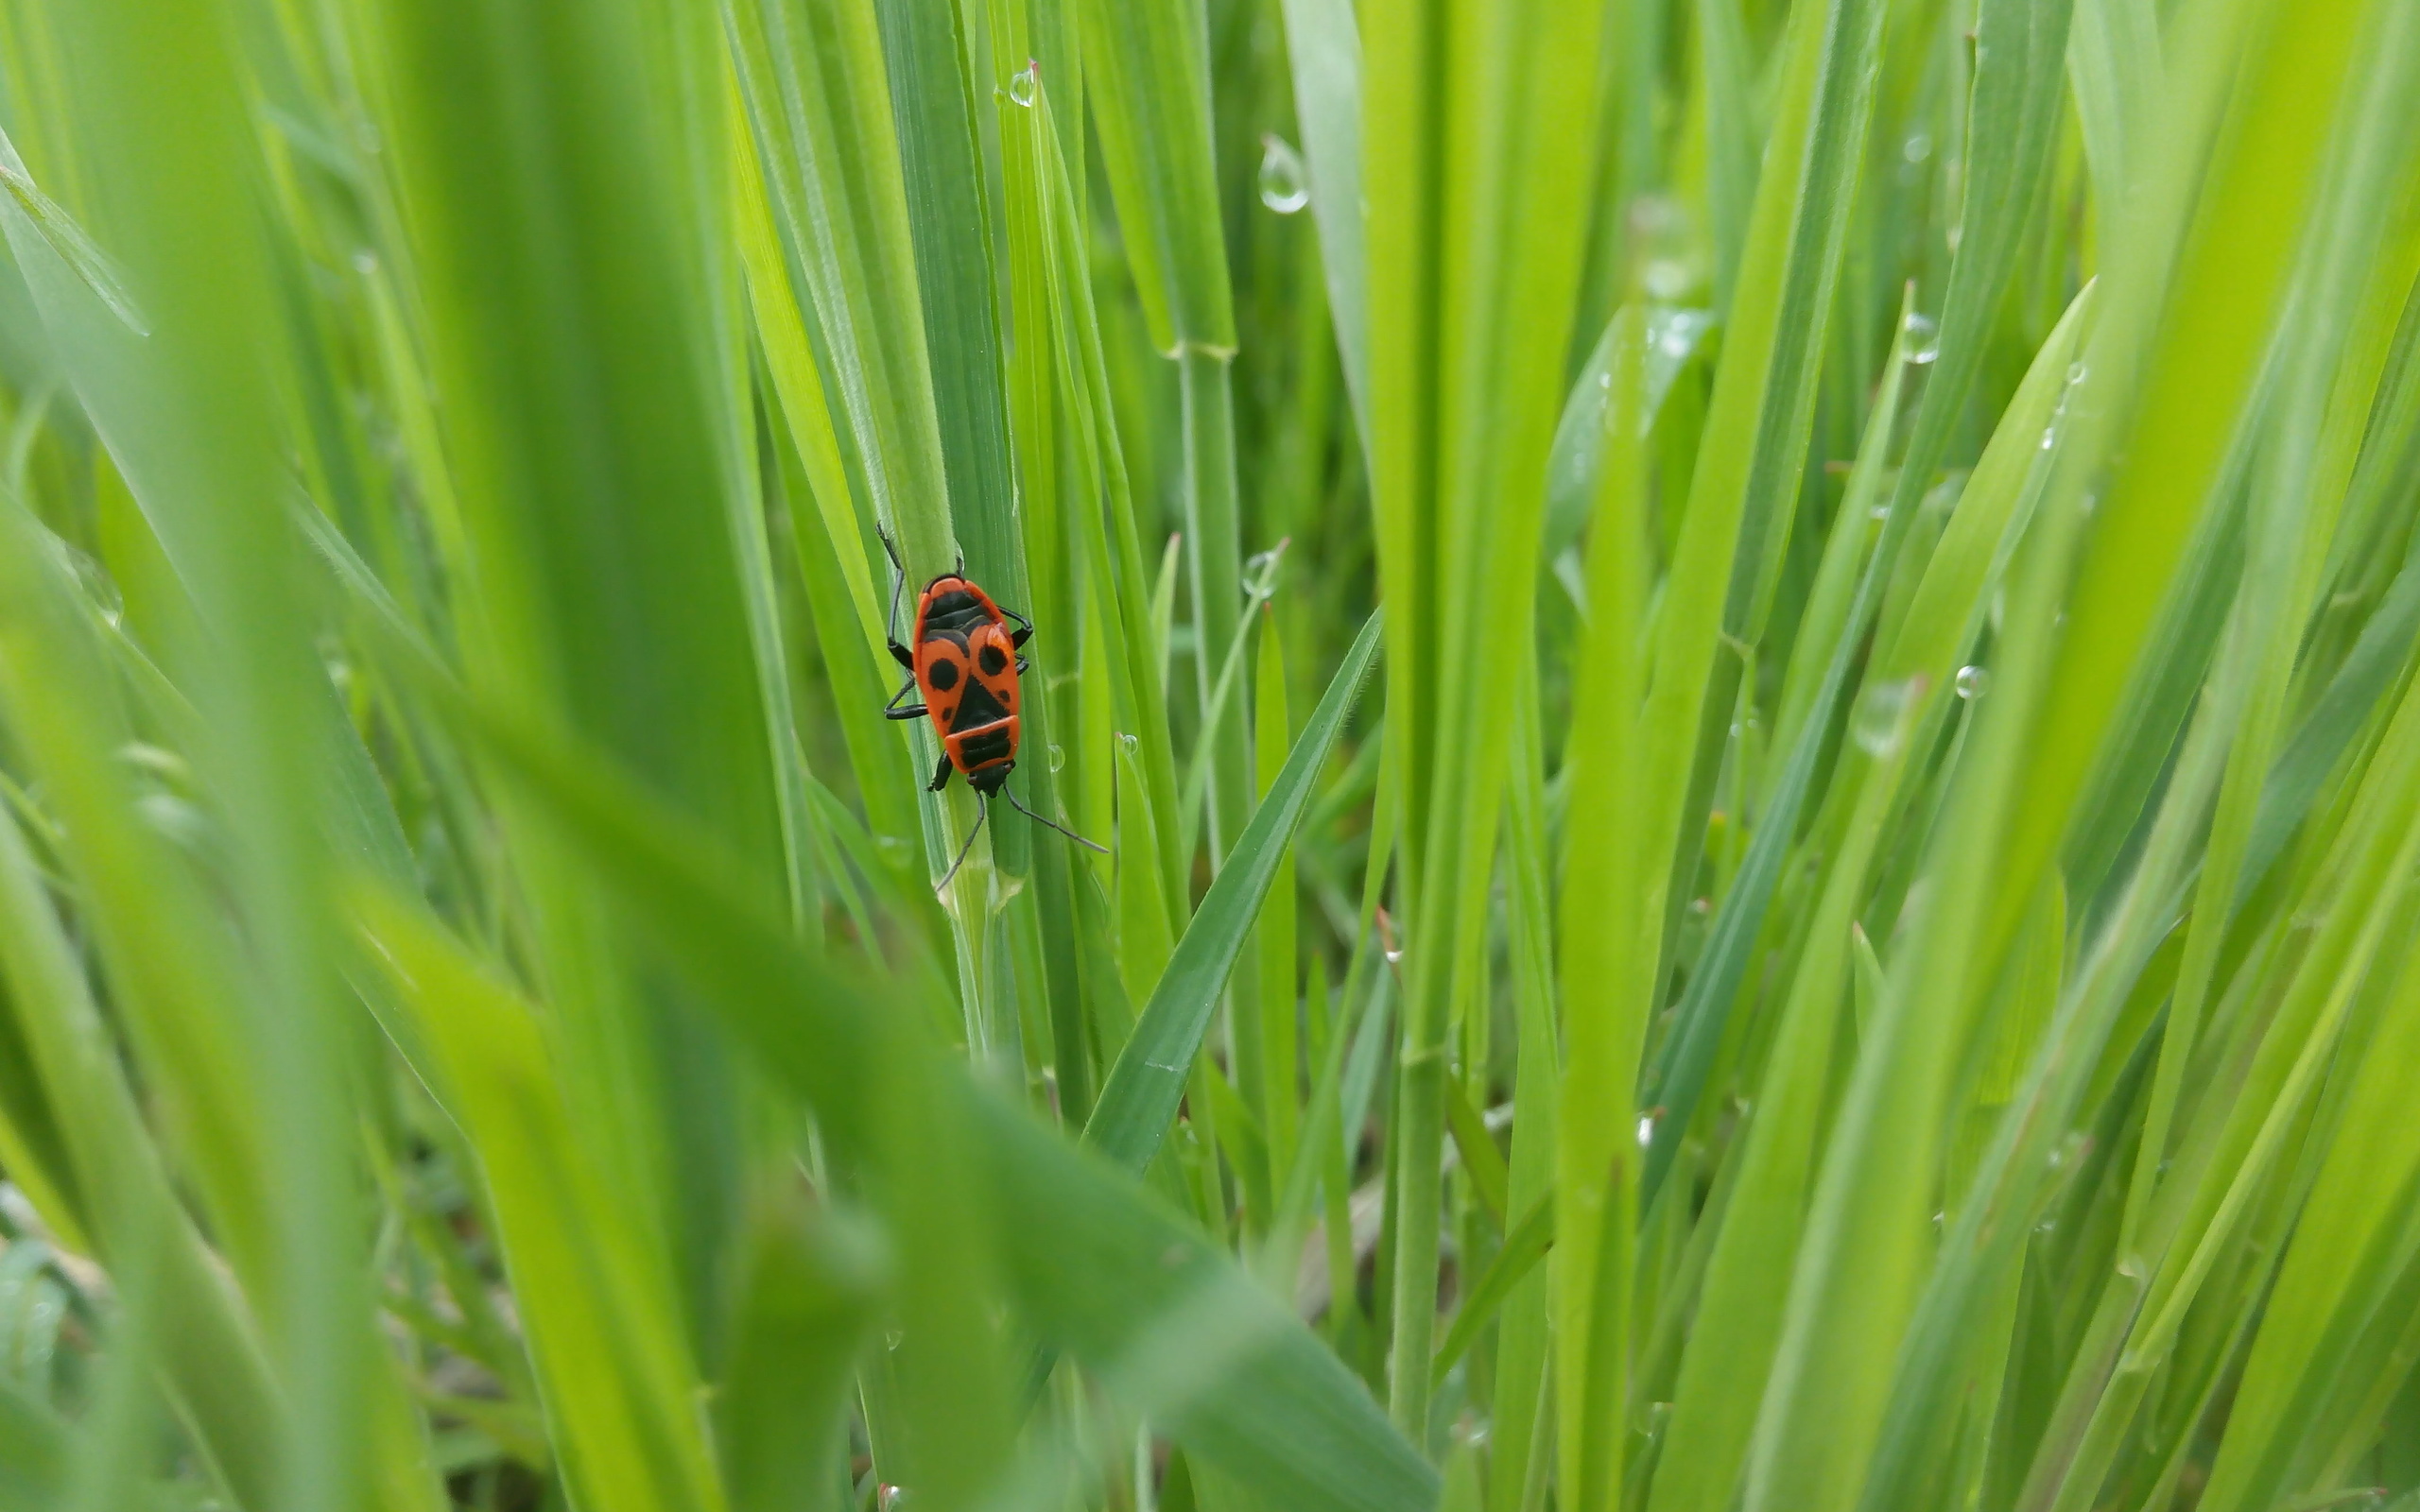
[1084,614,1379,1171]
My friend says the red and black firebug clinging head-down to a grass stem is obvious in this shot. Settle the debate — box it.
[883,537,1108,888]
